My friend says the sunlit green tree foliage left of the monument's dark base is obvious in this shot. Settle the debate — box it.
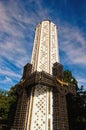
[0,87,17,123]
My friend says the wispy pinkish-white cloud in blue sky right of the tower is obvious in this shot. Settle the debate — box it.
[60,25,86,65]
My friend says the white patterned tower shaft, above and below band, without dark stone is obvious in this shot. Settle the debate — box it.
[27,20,59,130]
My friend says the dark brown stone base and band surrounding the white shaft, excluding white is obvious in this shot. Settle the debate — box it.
[11,63,76,130]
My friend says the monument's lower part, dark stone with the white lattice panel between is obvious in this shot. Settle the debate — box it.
[11,63,76,130]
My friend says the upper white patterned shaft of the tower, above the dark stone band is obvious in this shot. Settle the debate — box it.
[31,20,59,74]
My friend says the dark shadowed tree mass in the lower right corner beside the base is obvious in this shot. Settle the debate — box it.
[67,89,86,130]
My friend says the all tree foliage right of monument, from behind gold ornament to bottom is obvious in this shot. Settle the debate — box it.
[64,70,86,130]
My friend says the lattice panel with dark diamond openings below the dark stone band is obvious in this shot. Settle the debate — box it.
[31,86,48,130]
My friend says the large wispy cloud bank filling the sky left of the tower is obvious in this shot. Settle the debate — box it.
[0,0,51,70]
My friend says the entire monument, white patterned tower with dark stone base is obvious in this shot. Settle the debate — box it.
[11,20,76,130]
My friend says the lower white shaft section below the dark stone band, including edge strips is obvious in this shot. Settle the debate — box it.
[27,85,53,130]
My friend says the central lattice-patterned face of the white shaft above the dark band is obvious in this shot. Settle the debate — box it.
[38,21,49,72]
